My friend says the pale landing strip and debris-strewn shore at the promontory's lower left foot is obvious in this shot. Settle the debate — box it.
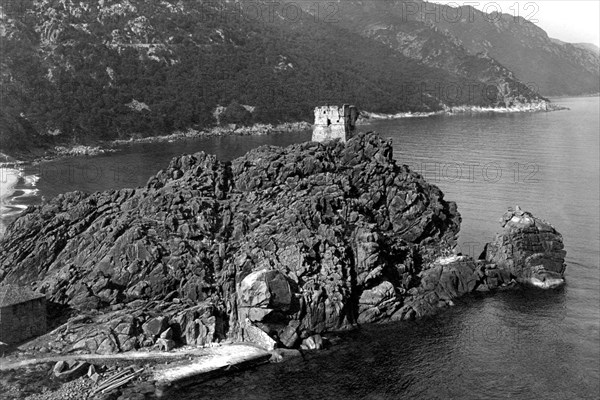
[0,342,272,400]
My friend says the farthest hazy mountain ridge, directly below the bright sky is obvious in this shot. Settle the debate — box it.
[400,1,600,96]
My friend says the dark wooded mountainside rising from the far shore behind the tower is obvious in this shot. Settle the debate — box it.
[0,0,597,152]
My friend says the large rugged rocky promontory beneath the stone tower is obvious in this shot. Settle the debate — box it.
[0,133,564,354]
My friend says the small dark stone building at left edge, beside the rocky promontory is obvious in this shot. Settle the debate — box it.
[0,285,46,344]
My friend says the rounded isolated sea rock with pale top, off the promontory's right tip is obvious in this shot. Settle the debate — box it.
[480,206,566,289]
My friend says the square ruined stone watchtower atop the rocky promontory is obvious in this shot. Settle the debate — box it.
[312,104,358,142]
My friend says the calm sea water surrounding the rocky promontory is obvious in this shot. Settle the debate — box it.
[5,97,600,400]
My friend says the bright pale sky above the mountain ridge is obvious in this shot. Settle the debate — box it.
[428,0,600,46]
